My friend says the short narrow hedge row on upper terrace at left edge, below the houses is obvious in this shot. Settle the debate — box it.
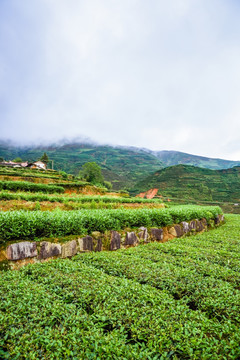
[0,181,64,194]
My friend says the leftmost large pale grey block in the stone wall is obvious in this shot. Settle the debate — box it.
[6,241,38,260]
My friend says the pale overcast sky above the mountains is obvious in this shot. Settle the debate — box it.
[0,0,240,160]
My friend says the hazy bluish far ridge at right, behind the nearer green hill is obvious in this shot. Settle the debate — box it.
[151,150,240,170]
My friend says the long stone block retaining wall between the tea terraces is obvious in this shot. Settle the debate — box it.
[0,215,224,269]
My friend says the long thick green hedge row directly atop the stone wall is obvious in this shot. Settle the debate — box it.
[0,206,222,241]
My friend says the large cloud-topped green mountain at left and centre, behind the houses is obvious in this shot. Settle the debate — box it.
[0,143,163,190]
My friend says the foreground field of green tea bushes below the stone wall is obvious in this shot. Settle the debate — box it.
[0,215,240,360]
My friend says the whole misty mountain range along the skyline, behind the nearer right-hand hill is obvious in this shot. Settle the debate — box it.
[0,141,240,190]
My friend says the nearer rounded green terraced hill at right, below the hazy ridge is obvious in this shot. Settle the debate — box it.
[133,165,240,202]
